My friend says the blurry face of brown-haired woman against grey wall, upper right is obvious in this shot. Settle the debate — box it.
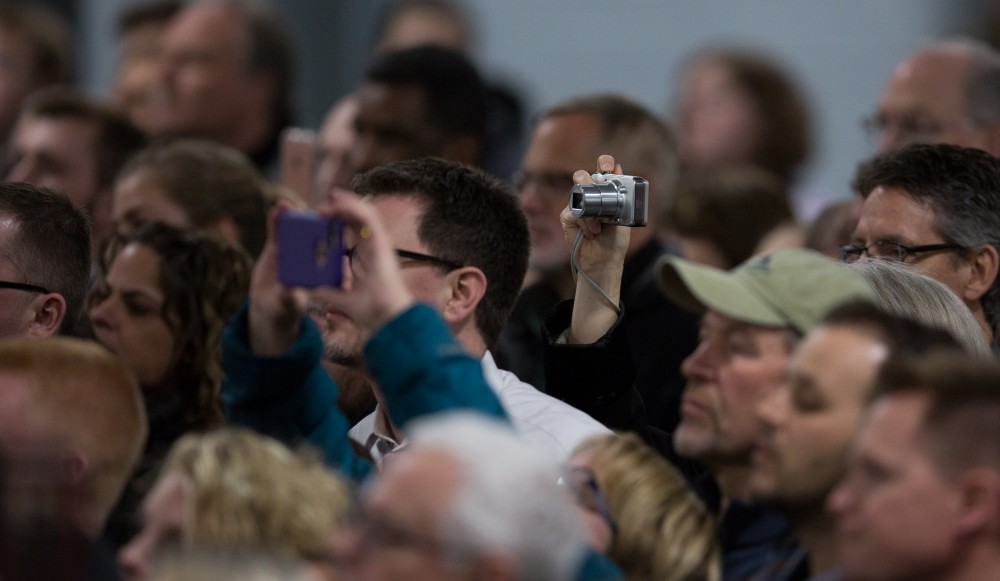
[678,58,763,169]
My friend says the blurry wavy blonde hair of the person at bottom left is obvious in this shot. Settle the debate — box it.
[161,428,349,559]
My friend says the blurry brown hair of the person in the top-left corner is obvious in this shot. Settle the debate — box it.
[0,2,74,87]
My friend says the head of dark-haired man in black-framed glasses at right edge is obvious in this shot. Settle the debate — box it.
[841,144,1000,339]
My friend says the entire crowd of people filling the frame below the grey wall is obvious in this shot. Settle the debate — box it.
[0,0,1000,581]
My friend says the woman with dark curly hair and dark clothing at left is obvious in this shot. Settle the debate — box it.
[88,223,252,544]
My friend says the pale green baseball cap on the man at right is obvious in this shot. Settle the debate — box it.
[654,248,875,333]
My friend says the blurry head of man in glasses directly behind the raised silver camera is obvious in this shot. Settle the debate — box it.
[515,94,677,272]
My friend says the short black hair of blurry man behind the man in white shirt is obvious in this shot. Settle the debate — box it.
[365,46,487,143]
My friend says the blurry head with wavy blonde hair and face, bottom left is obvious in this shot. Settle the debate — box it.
[119,429,349,581]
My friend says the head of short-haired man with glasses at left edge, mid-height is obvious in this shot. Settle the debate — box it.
[0,182,91,337]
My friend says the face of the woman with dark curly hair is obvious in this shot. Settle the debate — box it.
[88,243,174,392]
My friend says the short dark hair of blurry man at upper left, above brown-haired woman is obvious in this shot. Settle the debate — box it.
[21,87,147,189]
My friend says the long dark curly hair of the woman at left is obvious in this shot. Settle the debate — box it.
[91,222,253,429]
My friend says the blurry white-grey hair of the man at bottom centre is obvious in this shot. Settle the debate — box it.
[407,413,585,581]
